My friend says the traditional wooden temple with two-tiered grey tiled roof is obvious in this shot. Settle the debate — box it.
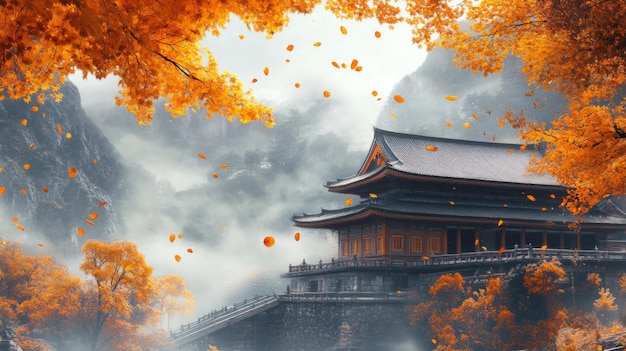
[284,128,626,292]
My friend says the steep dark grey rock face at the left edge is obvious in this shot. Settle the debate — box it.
[0,83,123,254]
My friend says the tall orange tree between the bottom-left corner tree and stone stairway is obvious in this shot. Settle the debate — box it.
[79,241,159,351]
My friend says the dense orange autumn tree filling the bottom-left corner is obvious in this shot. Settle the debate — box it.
[0,240,80,350]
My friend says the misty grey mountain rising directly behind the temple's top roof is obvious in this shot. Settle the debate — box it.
[377,48,566,142]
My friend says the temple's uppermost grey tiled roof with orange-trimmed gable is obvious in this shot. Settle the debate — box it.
[326,128,558,189]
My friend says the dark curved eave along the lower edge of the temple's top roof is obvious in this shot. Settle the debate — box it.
[326,166,567,193]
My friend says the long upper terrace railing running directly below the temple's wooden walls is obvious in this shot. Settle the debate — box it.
[289,248,626,273]
